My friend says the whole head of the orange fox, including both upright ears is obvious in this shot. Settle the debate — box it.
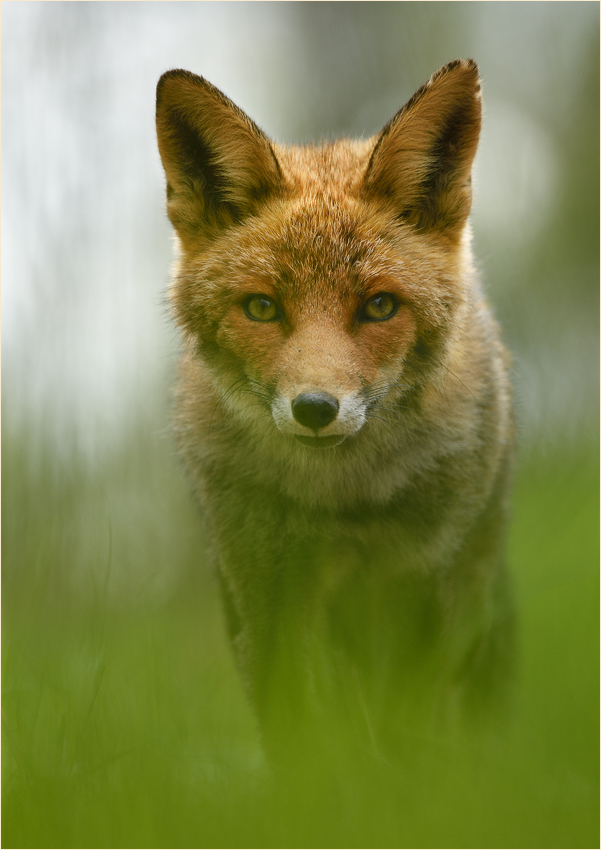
[156,60,481,448]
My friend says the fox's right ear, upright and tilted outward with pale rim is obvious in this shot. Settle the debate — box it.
[364,59,482,237]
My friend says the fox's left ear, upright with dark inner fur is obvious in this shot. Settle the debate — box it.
[156,70,280,241]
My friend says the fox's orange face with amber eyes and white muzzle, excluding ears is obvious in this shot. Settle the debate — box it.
[183,196,444,448]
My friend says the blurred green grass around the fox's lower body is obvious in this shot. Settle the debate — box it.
[2,435,599,848]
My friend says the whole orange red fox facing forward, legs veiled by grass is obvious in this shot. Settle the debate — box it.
[156,59,515,763]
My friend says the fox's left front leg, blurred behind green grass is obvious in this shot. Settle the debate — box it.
[220,528,328,762]
